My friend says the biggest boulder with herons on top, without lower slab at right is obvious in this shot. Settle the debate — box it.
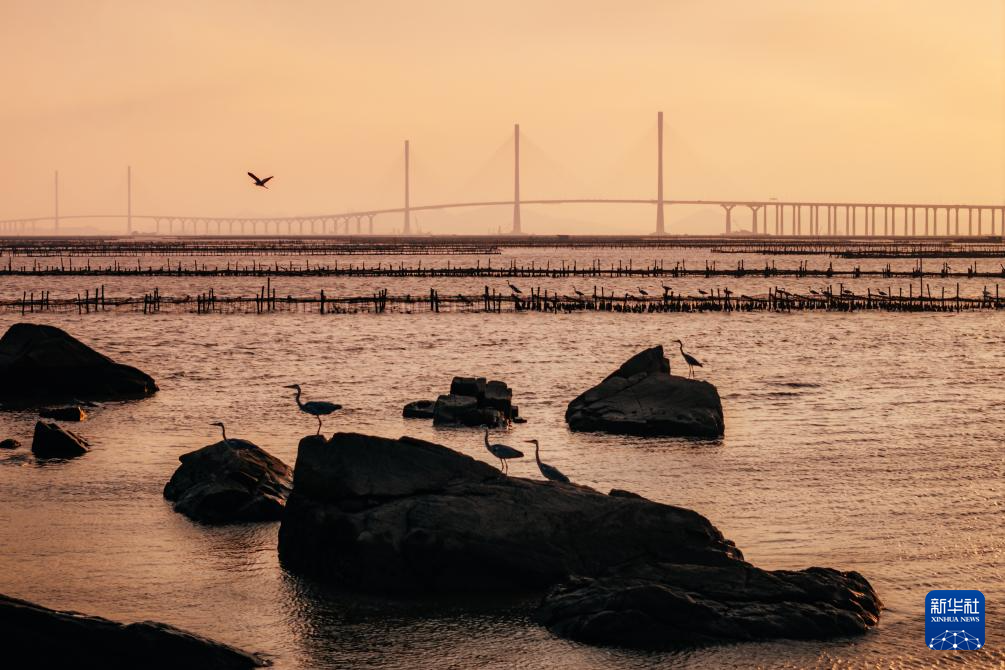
[279,433,746,592]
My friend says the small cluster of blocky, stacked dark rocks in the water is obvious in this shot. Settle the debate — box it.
[402,377,525,428]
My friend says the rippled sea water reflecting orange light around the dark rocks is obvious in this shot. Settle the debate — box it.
[0,249,1005,670]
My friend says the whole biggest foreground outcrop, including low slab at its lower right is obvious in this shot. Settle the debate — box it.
[279,433,880,647]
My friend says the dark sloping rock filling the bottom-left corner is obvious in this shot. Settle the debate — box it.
[0,595,270,670]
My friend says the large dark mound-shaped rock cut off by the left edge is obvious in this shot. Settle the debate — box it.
[0,323,157,404]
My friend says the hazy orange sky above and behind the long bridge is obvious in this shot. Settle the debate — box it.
[0,0,1005,233]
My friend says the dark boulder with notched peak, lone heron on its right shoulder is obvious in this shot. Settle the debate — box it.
[566,347,725,438]
